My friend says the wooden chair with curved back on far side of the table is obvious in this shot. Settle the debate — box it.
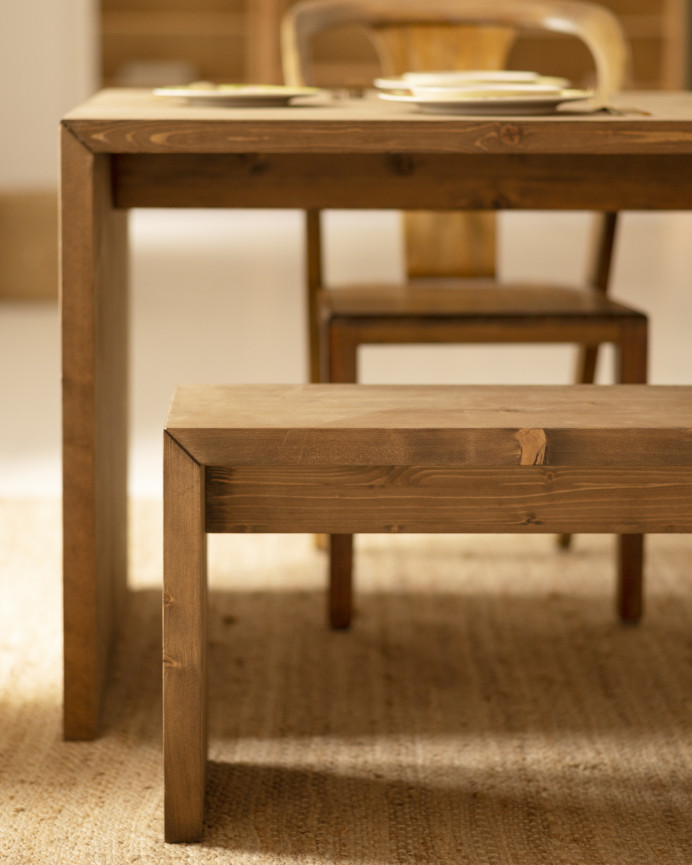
[281,0,647,627]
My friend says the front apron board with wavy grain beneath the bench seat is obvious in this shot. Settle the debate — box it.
[206,465,692,534]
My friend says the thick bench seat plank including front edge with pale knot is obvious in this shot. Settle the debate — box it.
[166,384,692,466]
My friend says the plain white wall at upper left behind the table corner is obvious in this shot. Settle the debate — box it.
[0,0,97,190]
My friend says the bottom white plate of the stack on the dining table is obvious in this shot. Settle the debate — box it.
[378,90,594,114]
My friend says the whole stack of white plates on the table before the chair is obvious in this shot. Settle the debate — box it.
[375,70,594,114]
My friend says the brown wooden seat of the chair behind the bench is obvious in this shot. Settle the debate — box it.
[319,280,646,321]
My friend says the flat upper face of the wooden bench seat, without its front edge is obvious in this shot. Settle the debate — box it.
[166,384,692,430]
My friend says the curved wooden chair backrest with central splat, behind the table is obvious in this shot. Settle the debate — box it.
[281,0,629,277]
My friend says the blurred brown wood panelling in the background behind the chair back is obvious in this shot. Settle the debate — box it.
[100,0,688,89]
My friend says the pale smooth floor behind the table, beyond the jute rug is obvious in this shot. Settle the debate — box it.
[0,210,692,497]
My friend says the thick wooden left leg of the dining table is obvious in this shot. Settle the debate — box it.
[61,129,128,739]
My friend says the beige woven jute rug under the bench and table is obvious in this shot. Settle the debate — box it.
[0,492,692,865]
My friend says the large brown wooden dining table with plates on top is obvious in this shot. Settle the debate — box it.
[61,89,692,739]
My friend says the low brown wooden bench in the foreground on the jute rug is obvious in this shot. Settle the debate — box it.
[163,384,692,841]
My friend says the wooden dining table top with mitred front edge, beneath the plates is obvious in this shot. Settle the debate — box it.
[62,88,692,155]
